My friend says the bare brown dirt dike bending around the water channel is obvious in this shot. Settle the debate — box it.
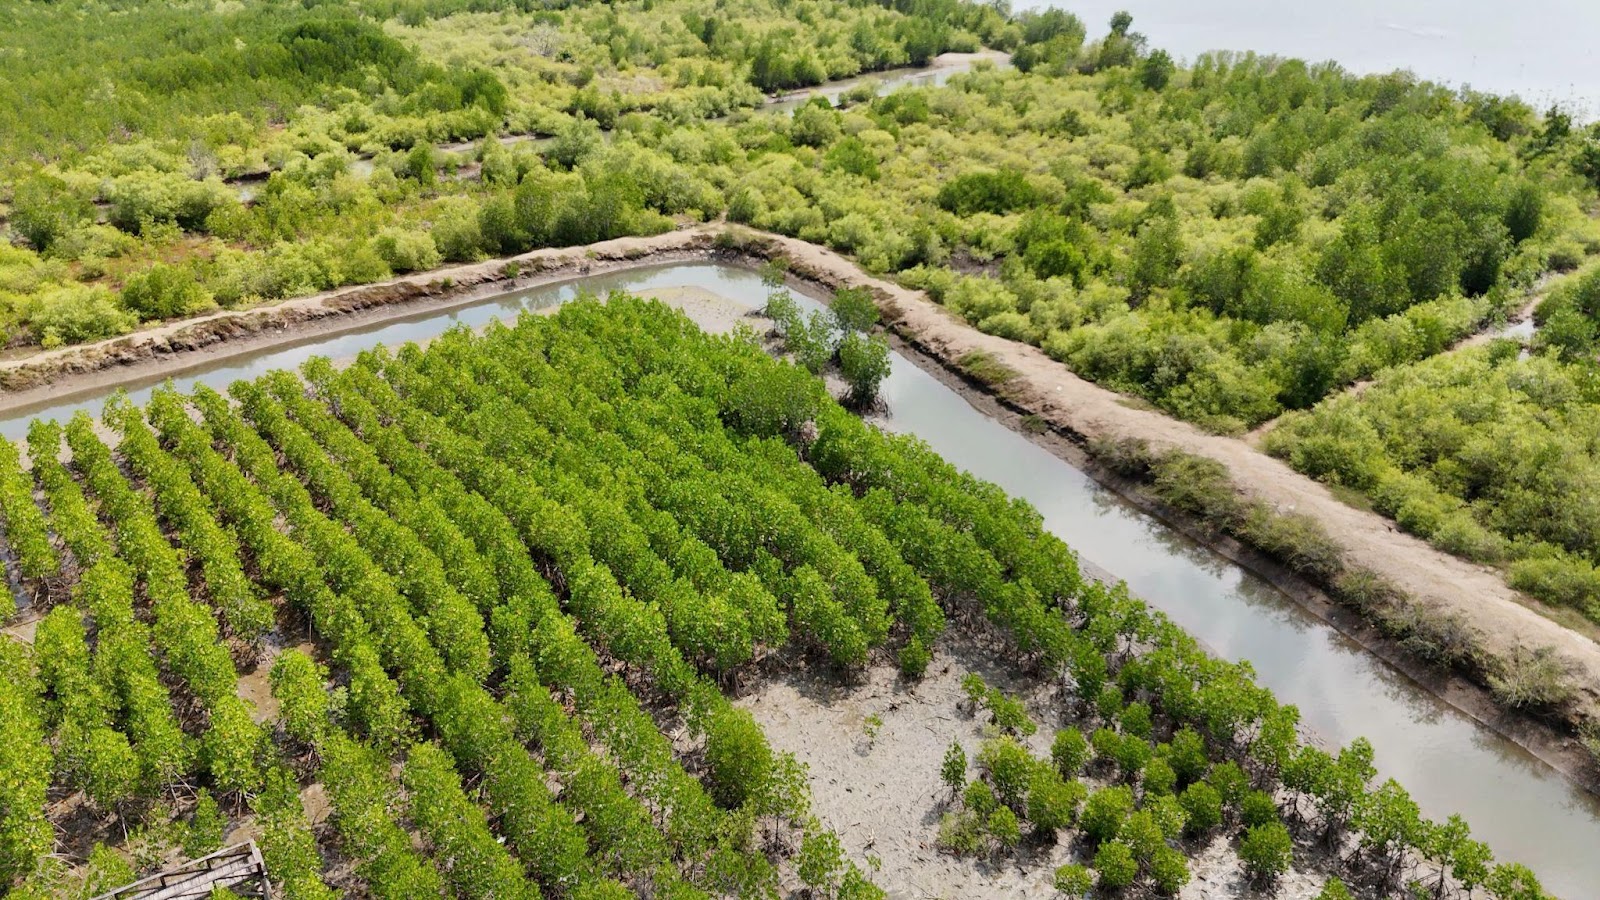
[12,224,1600,730]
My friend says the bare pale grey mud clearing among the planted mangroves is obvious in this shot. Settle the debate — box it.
[738,639,1323,900]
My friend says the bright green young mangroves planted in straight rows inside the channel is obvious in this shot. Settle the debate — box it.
[0,224,1561,897]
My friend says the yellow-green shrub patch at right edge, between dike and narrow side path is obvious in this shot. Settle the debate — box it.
[1269,337,1600,615]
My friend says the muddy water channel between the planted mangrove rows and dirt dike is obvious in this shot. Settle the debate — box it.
[0,263,1600,900]
